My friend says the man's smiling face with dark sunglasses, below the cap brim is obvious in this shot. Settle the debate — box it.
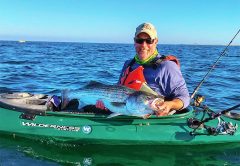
[134,33,158,60]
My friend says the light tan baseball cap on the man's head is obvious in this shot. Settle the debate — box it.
[135,23,158,39]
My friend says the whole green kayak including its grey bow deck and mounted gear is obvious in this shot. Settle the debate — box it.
[0,93,240,145]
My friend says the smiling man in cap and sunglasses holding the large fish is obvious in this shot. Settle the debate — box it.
[96,23,190,116]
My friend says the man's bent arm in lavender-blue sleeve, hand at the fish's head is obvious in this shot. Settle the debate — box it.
[155,61,190,116]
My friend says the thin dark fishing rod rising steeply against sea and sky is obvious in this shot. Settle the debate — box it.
[191,29,240,99]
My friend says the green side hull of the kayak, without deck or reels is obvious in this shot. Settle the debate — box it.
[0,108,240,145]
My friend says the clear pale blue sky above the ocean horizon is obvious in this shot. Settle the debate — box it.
[0,0,240,45]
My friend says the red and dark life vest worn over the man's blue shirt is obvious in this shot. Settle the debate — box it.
[120,55,180,91]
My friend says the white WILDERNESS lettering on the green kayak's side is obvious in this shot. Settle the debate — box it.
[22,122,80,131]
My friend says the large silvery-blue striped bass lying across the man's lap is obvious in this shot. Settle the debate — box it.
[64,82,164,117]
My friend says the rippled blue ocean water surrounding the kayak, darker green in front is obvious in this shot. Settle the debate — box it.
[0,41,240,166]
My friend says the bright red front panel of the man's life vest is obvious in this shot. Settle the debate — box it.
[120,66,146,91]
